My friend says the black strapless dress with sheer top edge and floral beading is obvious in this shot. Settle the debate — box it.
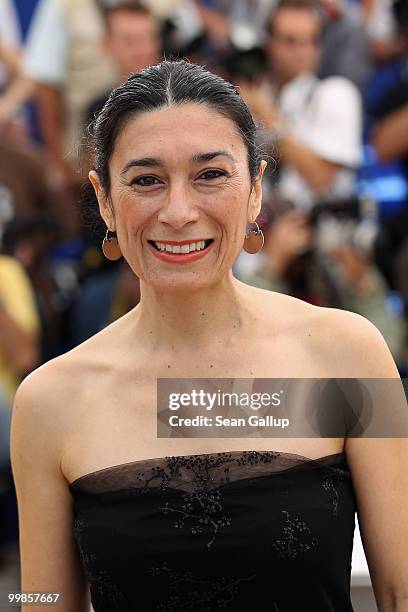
[70,451,356,612]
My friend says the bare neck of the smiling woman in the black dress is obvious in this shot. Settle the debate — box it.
[128,271,254,355]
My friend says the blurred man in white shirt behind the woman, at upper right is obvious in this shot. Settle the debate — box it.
[238,0,362,210]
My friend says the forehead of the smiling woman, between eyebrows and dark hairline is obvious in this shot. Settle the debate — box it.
[111,103,246,165]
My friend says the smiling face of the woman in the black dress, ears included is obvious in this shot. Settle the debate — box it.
[90,103,266,291]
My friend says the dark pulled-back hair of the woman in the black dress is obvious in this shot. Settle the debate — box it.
[82,59,262,234]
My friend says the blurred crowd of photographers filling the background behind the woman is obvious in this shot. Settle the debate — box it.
[0,0,408,571]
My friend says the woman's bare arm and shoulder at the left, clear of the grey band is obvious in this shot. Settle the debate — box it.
[10,360,90,612]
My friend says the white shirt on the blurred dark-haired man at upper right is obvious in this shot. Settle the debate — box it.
[278,74,362,209]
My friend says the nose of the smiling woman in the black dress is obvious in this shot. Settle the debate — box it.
[157,181,200,229]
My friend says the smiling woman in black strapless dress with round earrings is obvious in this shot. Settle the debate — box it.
[11,61,408,612]
